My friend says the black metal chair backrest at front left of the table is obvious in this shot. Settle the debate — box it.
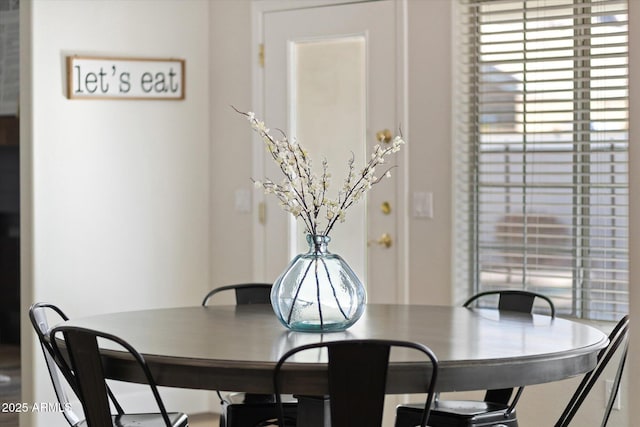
[50,325,171,427]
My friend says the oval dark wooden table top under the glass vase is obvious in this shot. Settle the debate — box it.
[62,304,607,395]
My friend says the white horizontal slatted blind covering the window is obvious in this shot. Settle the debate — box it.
[454,0,629,320]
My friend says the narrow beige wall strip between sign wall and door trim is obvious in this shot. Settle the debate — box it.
[210,0,257,286]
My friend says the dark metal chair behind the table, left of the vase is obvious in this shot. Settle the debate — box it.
[202,283,297,427]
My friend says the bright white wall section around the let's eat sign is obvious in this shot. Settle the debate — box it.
[21,0,211,426]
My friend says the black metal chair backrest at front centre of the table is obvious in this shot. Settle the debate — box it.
[273,340,438,427]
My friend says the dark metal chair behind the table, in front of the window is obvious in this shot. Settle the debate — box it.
[395,290,556,427]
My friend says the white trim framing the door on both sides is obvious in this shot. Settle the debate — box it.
[251,0,410,304]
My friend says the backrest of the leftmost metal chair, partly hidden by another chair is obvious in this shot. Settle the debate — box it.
[29,303,80,426]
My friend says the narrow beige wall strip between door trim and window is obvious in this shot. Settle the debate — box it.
[407,0,454,305]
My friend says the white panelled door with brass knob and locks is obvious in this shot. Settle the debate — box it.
[254,0,406,303]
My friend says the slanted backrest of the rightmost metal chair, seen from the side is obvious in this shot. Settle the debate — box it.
[555,315,629,427]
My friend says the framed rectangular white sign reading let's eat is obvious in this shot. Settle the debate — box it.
[67,56,185,100]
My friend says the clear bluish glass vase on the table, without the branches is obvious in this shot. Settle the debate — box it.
[271,235,366,332]
